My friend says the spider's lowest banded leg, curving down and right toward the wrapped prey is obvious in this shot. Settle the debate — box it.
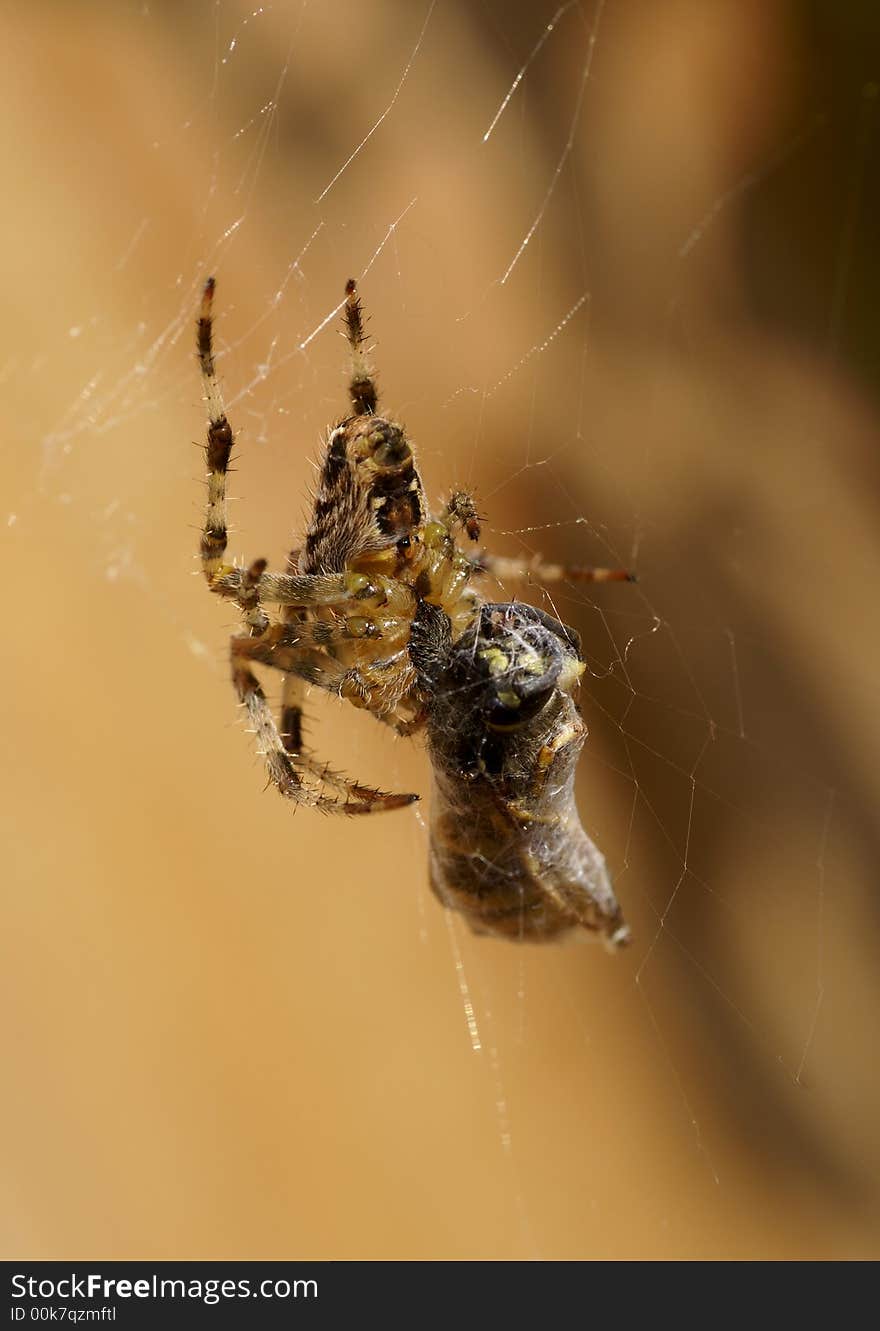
[230,636,418,815]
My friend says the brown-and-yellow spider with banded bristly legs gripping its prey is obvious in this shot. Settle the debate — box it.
[197,277,632,815]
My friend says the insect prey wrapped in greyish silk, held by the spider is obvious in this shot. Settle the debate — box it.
[410,602,630,949]
